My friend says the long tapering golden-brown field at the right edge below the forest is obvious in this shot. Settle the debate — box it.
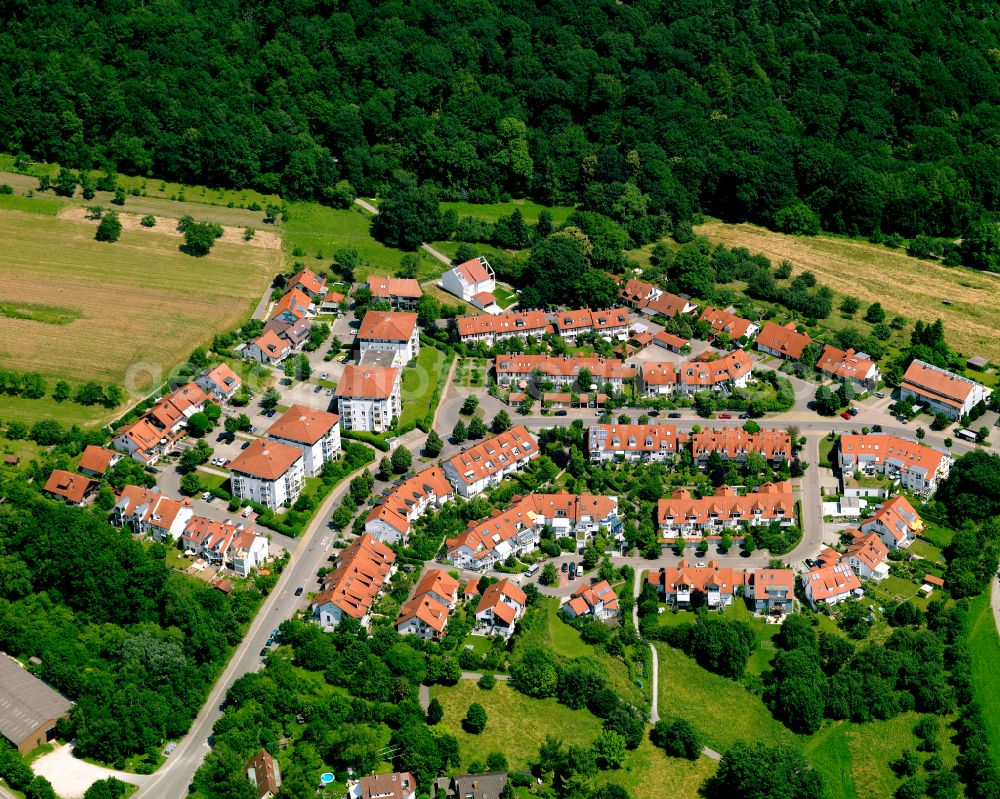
[695,217,1000,360]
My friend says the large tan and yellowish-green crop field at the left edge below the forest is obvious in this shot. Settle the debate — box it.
[0,209,281,404]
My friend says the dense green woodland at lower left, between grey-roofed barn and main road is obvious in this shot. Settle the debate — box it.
[0,479,261,771]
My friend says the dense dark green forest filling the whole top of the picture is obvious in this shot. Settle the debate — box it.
[0,0,1000,239]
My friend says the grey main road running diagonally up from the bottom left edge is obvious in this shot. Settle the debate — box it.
[134,456,375,799]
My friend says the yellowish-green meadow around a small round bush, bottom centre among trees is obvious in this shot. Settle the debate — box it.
[431,680,601,770]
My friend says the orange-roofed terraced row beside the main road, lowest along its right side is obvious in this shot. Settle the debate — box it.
[309,533,396,627]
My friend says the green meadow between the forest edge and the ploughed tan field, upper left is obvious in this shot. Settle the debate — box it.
[284,202,444,281]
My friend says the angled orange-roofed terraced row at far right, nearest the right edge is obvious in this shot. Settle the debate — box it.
[840,433,953,497]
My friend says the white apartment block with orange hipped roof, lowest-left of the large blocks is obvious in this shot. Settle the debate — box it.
[229,438,305,510]
